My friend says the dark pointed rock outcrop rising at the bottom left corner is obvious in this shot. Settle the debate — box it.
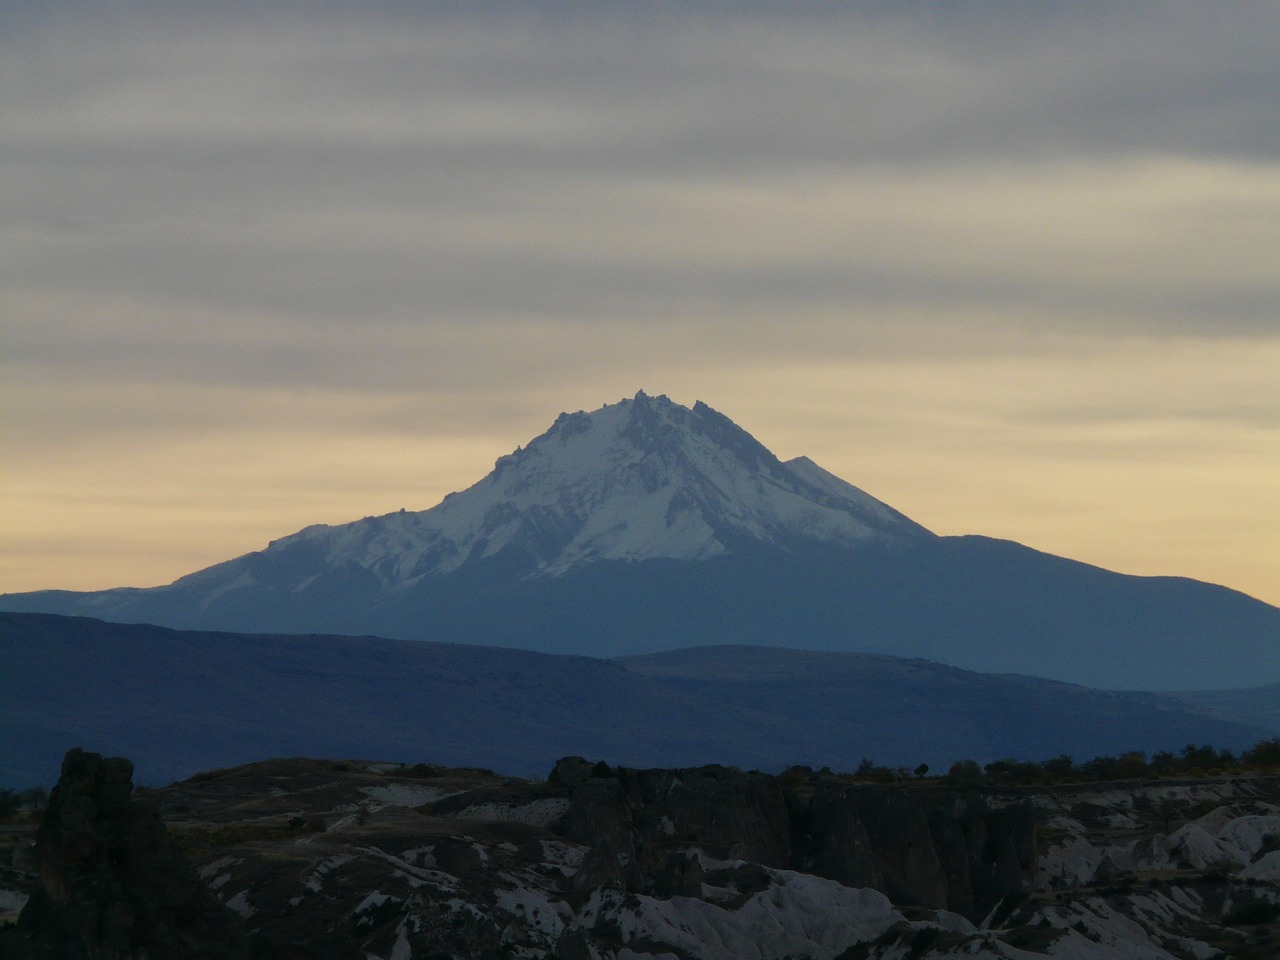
[14,749,248,960]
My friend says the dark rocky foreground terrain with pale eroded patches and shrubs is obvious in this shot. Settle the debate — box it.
[0,751,1280,960]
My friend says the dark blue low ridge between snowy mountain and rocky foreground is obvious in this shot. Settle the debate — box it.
[0,613,1266,787]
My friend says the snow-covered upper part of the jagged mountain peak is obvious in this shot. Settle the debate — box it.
[179,392,932,589]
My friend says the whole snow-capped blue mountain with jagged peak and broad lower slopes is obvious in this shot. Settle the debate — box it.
[0,393,1280,690]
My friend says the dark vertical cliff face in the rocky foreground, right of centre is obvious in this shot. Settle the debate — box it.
[552,759,1036,919]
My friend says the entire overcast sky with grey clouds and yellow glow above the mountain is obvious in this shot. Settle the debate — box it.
[0,0,1280,603]
